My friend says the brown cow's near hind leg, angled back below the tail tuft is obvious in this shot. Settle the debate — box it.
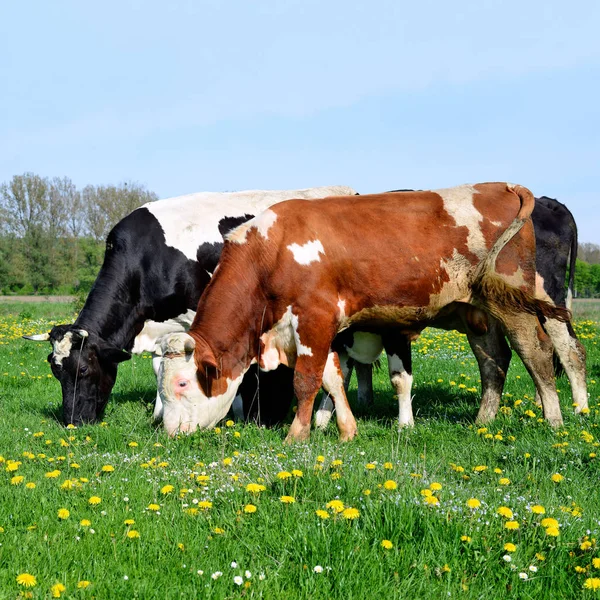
[501,313,563,427]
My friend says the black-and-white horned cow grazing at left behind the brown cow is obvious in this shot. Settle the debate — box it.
[27,186,355,425]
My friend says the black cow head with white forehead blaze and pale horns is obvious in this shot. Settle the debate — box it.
[23,325,131,425]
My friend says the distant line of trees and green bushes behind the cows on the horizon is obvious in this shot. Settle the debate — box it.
[0,173,600,298]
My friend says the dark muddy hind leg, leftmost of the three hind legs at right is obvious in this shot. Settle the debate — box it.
[467,317,511,423]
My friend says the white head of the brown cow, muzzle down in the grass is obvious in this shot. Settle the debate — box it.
[158,333,243,436]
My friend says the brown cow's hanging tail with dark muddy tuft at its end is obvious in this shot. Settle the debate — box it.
[471,185,571,322]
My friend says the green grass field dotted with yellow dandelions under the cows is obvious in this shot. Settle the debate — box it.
[0,302,600,600]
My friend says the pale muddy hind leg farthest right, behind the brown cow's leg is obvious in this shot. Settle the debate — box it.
[544,319,588,413]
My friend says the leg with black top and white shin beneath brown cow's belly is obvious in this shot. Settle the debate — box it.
[383,333,415,427]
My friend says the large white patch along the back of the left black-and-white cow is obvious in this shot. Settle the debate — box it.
[142,186,355,261]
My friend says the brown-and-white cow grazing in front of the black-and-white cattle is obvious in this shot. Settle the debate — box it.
[159,183,569,440]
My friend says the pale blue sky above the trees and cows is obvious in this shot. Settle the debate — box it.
[0,0,600,243]
